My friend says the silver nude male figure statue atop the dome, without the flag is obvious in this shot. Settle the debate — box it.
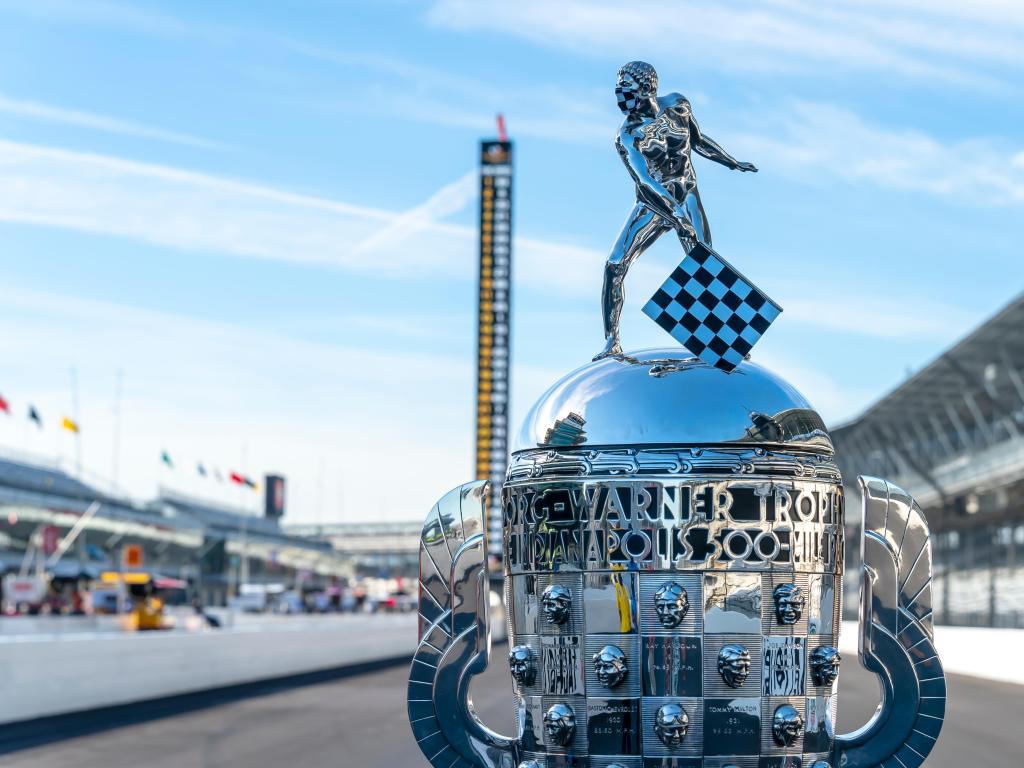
[594,61,758,359]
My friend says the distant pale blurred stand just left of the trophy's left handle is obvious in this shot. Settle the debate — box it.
[285,522,423,578]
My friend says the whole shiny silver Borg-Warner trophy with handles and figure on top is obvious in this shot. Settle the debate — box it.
[409,61,945,768]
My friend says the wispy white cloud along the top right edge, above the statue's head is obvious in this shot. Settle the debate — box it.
[428,0,1024,86]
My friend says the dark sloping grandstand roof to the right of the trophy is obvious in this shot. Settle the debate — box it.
[830,294,1024,520]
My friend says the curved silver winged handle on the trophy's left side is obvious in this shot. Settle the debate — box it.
[408,481,516,768]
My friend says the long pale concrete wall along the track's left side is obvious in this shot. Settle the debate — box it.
[0,613,417,723]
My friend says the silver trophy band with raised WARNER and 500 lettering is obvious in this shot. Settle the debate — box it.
[503,480,843,569]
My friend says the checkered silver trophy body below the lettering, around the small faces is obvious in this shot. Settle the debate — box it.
[512,568,838,768]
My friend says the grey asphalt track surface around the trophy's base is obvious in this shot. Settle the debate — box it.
[0,646,1024,768]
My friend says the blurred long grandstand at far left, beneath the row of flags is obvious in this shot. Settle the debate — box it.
[0,459,353,605]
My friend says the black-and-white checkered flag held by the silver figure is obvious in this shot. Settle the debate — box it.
[643,244,782,371]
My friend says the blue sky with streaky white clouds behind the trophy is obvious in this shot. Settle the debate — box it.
[0,0,1024,520]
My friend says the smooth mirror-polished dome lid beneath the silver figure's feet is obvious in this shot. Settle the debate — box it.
[512,349,833,455]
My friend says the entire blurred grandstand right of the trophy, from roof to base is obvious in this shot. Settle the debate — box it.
[831,295,1024,627]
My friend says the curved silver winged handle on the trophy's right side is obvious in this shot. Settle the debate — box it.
[835,477,946,768]
